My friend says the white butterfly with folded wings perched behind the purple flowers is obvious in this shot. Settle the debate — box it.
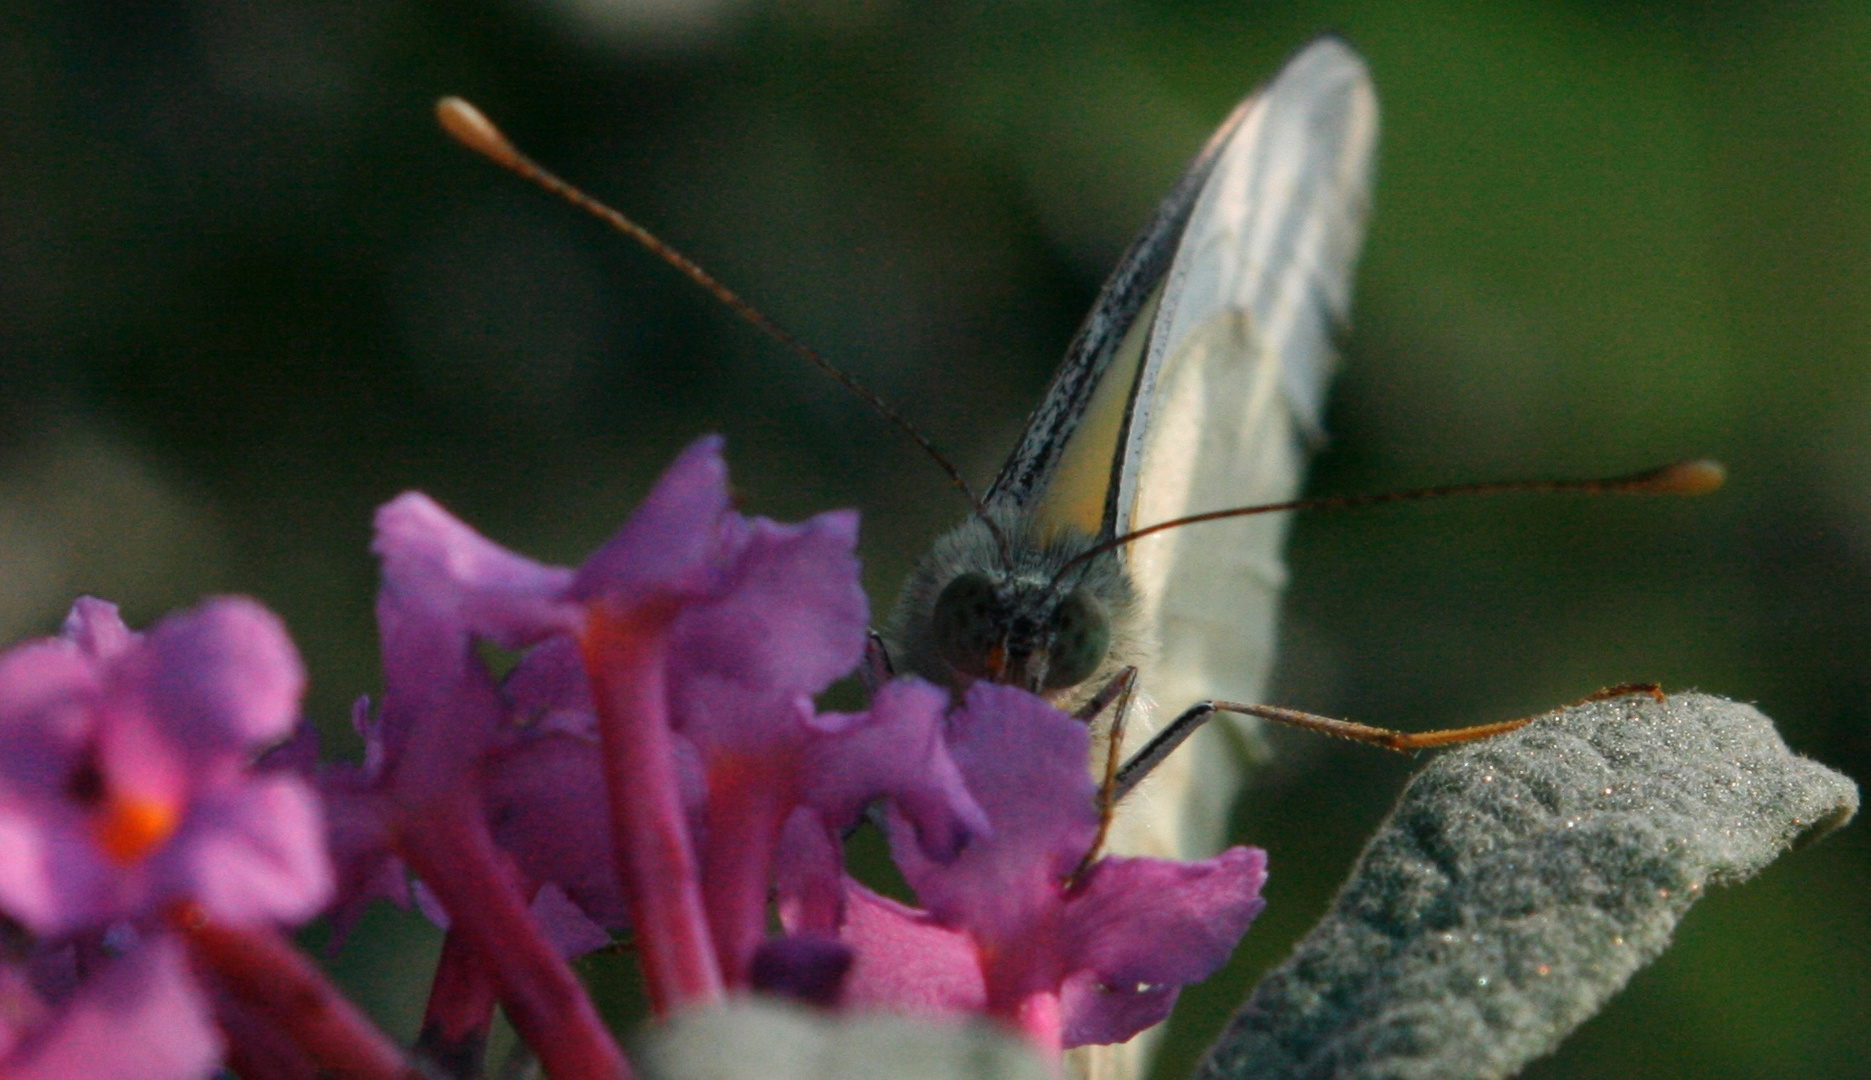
[885,37,1377,872]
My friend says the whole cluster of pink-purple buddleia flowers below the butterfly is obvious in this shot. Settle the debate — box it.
[0,438,1265,1080]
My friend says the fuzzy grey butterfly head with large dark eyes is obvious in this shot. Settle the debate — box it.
[891,511,1136,702]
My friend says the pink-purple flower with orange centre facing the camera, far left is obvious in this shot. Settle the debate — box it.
[0,599,331,936]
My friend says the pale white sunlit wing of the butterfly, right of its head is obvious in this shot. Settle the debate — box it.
[1113,39,1377,857]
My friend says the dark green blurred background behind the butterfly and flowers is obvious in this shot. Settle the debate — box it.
[0,0,1871,1078]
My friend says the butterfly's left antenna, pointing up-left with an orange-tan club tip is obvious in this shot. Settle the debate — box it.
[436,97,1007,516]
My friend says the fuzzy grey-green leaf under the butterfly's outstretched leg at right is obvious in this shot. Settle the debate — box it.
[1197,694,1858,1080]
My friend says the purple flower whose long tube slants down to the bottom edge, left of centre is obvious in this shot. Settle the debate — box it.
[310,492,623,1074]
